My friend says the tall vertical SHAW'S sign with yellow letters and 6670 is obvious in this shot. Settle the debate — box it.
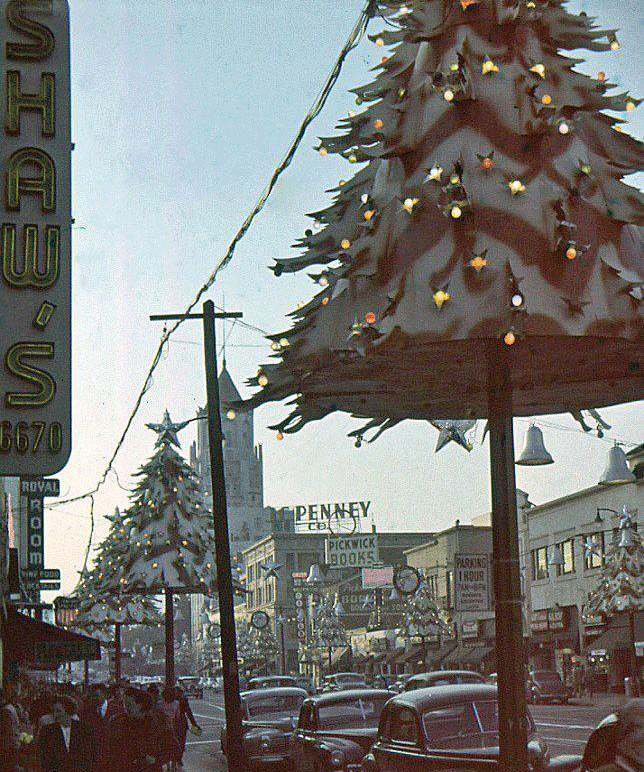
[0,0,72,475]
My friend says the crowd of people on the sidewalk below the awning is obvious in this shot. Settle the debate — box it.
[0,678,201,772]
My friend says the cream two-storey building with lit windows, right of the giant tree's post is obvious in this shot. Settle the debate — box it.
[520,452,644,688]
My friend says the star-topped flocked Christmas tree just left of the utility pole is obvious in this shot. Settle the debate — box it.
[123,410,215,593]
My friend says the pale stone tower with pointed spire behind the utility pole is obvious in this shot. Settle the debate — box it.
[190,358,270,557]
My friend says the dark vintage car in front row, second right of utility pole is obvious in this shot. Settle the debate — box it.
[292,689,391,772]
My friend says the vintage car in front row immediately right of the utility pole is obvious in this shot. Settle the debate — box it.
[221,687,308,772]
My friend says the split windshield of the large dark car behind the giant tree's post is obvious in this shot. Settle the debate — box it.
[423,700,534,749]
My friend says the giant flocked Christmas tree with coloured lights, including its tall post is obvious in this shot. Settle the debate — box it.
[239,0,644,772]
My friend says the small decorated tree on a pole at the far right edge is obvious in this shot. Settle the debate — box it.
[586,507,644,680]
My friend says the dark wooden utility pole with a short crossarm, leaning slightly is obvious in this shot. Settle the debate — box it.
[150,300,246,772]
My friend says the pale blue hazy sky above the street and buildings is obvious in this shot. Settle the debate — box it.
[45,0,643,590]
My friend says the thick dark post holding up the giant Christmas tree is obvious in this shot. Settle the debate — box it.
[487,342,528,772]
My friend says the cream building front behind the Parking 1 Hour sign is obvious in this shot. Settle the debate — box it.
[402,520,495,671]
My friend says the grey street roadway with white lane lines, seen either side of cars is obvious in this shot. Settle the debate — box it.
[184,692,612,772]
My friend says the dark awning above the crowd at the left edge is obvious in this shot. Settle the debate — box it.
[2,606,101,667]
